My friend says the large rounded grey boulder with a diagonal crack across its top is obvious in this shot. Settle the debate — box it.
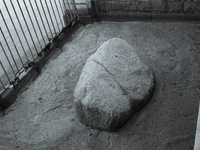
[74,38,154,131]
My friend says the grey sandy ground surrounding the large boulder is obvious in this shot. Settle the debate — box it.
[0,22,200,150]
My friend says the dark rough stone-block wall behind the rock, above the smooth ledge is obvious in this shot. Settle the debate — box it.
[92,0,200,13]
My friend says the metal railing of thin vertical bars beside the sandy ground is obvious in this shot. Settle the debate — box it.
[0,0,78,94]
